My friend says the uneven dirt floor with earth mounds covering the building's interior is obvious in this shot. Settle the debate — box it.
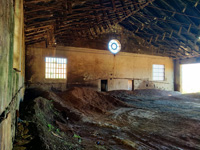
[14,88,200,150]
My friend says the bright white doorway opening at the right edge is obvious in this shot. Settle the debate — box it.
[181,63,200,93]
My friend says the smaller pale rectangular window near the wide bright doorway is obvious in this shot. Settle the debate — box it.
[153,65,165,81]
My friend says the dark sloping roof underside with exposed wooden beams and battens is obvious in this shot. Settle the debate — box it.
[24,0,200,59]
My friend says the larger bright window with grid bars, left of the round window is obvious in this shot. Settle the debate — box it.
[45,57,67,79]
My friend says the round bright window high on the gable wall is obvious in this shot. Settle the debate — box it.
[108,39,121,54]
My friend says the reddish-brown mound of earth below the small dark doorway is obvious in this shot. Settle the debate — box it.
[58,87,127,114]
